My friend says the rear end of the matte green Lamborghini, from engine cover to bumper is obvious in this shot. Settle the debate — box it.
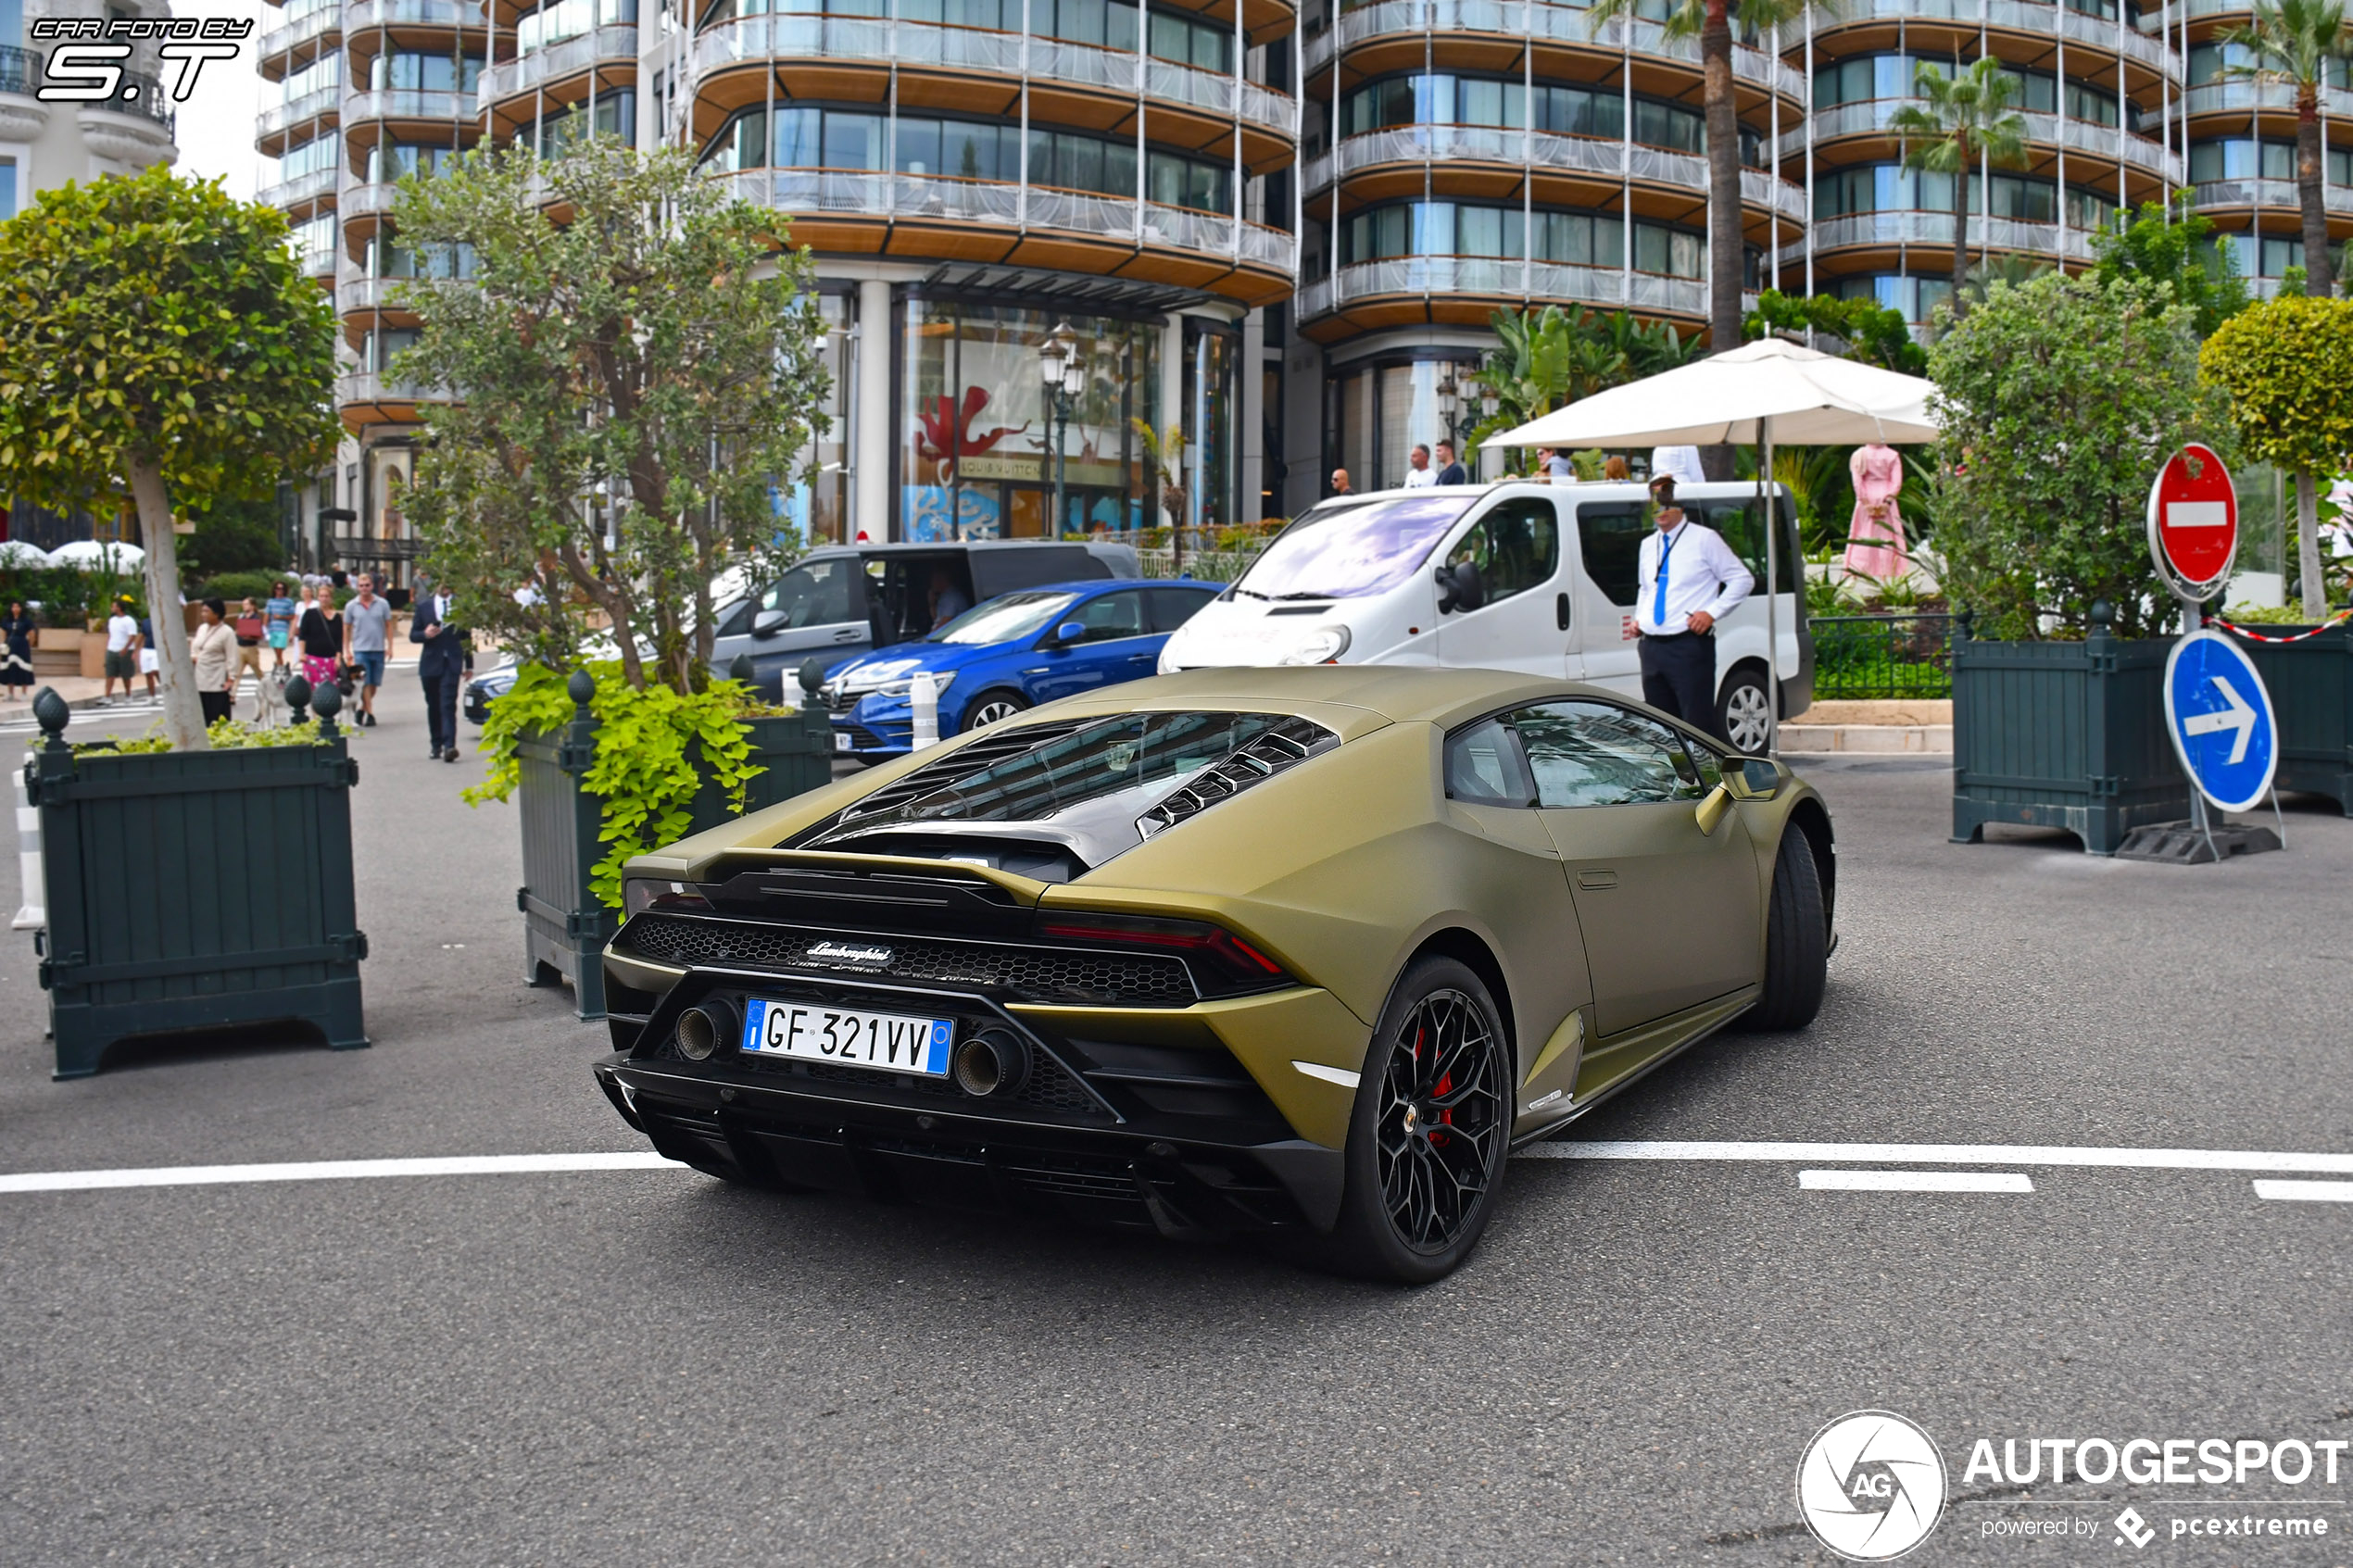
[598,703,1381,1235]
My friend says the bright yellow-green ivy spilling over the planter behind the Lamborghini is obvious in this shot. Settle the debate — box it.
[466,659,784,909]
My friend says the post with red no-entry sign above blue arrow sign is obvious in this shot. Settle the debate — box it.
[2118,442,2280,860]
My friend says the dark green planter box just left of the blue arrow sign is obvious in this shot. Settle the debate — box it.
[1953,616,2191,856]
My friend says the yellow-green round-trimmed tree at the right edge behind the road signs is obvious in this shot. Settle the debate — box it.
[2197,296,2353,621]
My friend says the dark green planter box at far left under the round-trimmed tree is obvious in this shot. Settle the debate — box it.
[23,694,367,1079]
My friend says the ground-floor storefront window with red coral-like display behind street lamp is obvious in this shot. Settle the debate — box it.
[899,298,1169,541]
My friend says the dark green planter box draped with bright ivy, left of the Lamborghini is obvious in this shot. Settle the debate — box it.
[515,674,833,1022]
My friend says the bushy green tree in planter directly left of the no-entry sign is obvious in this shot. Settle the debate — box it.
[1927,272,2233,637]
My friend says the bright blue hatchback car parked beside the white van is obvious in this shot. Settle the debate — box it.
[821,578,1224,761]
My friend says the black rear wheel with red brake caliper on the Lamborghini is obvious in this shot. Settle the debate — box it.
[1334,957,1513,1284]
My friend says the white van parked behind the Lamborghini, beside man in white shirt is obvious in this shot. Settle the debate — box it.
[1160,480,1814,752]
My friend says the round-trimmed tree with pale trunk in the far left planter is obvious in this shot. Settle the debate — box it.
[0,165,339,750]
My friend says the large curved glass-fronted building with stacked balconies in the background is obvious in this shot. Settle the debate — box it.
[257,0,2353,557]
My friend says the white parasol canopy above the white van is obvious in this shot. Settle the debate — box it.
[1485,339,1936,449]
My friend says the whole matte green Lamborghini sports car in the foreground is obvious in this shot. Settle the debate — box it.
[596,665,1835,1281]
